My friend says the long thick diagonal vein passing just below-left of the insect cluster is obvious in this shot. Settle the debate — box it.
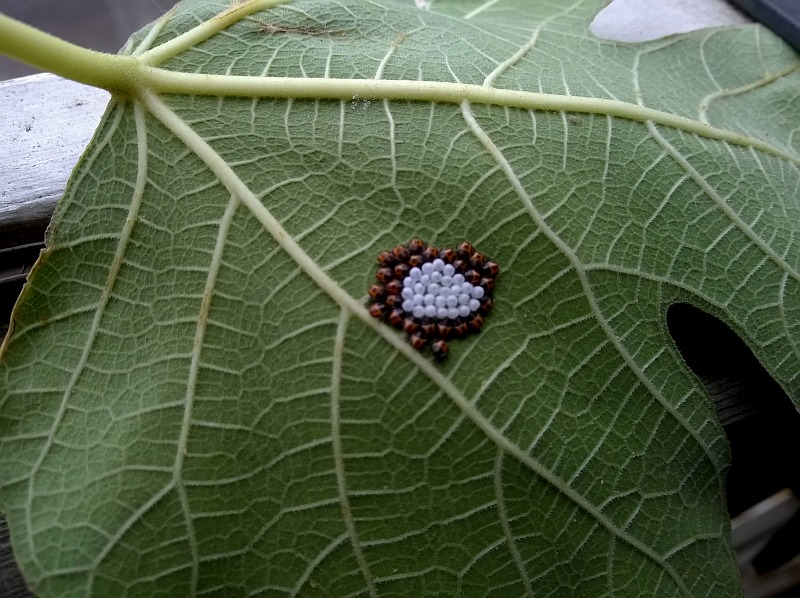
[143,89,689,595]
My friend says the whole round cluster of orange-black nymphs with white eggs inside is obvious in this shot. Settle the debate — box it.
[369,239,499,361]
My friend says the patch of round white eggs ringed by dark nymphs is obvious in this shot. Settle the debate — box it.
[400,258,485,320]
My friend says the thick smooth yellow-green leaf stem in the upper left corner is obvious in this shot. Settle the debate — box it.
[0,14,141,93]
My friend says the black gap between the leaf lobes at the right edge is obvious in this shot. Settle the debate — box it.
[667,303,800,572]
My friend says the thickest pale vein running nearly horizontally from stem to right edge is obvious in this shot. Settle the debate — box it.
[140,65,800,166]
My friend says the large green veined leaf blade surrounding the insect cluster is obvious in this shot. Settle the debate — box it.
[0,0,800,597]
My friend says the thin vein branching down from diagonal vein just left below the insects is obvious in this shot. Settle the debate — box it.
[331,309,378,598]
